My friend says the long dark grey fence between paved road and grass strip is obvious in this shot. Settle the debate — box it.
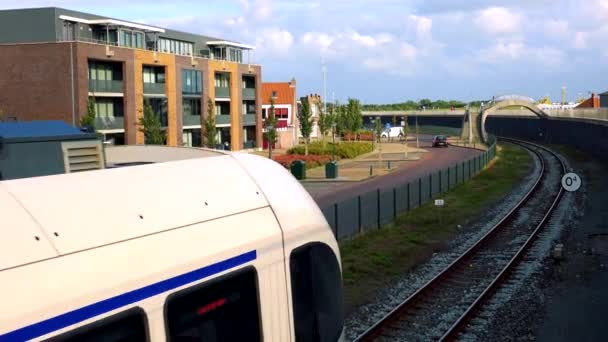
[321,136,496,240]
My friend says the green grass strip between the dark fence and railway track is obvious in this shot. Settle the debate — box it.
[340,144,532,313]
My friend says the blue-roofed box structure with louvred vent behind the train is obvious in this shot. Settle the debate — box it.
[0,121,105,180]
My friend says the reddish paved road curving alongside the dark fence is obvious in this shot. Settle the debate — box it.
[303,139,482,208]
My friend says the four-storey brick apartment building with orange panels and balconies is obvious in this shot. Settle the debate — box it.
[0,8,262,150]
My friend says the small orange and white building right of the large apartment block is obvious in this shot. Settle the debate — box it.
[262,79,298,148]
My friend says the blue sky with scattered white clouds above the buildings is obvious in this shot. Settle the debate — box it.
[0,0,608,103]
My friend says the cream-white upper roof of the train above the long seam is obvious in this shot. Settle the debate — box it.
[0,150,327,271]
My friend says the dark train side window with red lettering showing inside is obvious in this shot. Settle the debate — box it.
[165,267,261,341]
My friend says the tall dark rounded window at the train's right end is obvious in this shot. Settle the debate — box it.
[290,243,344,342]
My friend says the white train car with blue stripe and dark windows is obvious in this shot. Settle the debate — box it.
[0,153,343,341]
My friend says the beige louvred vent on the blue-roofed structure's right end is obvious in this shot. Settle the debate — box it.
[61,141,104,173]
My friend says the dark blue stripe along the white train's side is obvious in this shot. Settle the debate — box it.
[0,251,257,341]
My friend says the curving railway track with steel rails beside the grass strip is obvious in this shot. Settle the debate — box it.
[355,139,566,341]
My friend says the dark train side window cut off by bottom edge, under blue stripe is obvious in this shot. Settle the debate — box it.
[47,308,148,342]
